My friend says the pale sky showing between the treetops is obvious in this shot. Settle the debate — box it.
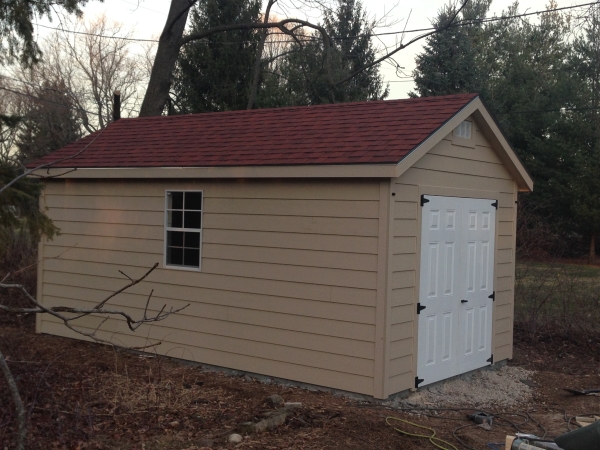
[39,0,564,99]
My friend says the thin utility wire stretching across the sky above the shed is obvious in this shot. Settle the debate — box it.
[36,1,600,44]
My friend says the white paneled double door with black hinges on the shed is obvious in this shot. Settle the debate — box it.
[416,196,497,386]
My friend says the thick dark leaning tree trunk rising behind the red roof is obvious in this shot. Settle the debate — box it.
[140,0,194,117]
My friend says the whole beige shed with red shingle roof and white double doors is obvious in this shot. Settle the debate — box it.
[30,94,532,399]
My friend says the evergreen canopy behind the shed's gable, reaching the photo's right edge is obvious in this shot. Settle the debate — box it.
[412,0,600,258]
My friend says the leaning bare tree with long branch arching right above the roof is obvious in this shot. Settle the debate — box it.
[140,0,469,116]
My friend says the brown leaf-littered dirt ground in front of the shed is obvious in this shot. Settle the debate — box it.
[0,314,600,450]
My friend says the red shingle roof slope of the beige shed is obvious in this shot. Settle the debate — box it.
[28,94,477,168]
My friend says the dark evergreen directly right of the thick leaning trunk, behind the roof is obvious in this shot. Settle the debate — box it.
[171,0,260,113]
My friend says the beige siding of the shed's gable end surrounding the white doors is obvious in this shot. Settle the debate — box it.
[386,118,517,395]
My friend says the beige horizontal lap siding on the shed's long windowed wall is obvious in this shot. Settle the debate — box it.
[40,180,379,394]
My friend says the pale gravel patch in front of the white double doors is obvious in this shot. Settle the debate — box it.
[401,366,534,409]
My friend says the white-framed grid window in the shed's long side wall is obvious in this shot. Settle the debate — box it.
[165,191,202,270]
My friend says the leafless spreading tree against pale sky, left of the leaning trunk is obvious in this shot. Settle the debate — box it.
[13,16,153,133]
